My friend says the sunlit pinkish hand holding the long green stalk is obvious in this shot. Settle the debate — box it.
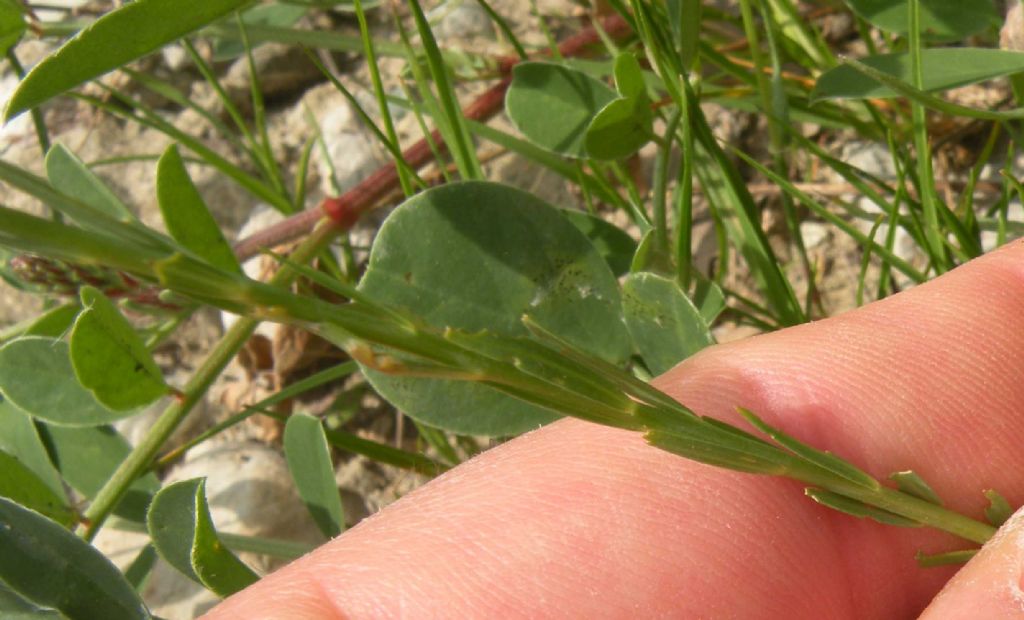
[201,242,1024,620]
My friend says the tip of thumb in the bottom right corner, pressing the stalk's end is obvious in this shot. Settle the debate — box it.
[921,508,1024,620]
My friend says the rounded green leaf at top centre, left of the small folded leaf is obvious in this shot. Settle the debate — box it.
[505,63,617,158]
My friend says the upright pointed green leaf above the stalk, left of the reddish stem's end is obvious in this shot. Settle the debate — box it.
[157,144,242,274]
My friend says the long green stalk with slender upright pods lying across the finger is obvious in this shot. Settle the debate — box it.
[0,186,995,543]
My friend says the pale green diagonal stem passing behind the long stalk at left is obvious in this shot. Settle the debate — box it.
[79,225,337,541]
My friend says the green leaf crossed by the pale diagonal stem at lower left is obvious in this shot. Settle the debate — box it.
[43,424,160,523]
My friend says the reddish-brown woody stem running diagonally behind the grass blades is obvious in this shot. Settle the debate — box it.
[234,15,631,260]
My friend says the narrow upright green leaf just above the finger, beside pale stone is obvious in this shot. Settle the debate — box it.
[285,414,345,538]
